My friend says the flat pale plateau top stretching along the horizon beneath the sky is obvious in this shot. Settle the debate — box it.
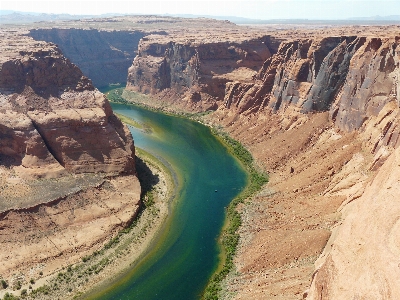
[0,16,400,49]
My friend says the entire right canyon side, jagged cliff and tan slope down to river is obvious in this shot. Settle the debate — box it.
[203,36,400,299]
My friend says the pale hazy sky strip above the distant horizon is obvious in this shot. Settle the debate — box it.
[0,0,400,19]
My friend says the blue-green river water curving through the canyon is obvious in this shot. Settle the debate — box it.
[91,104,247,300]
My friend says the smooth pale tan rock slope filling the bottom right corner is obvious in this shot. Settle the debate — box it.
[307,142,400,300]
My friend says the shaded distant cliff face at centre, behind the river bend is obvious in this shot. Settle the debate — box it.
[127,36,277,110]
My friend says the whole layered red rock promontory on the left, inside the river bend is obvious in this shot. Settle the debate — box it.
[0,31,140,282]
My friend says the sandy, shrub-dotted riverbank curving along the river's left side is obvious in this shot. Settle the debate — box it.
[0,149,175,299]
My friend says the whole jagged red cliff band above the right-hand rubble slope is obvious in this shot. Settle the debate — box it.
[225,37,398,132]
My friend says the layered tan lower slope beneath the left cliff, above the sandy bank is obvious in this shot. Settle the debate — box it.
[0,175,140,280]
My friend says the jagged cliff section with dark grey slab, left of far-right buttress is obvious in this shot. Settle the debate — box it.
[225,37,360,112]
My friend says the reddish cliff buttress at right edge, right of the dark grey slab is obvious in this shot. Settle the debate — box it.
[330,38,400,132]
